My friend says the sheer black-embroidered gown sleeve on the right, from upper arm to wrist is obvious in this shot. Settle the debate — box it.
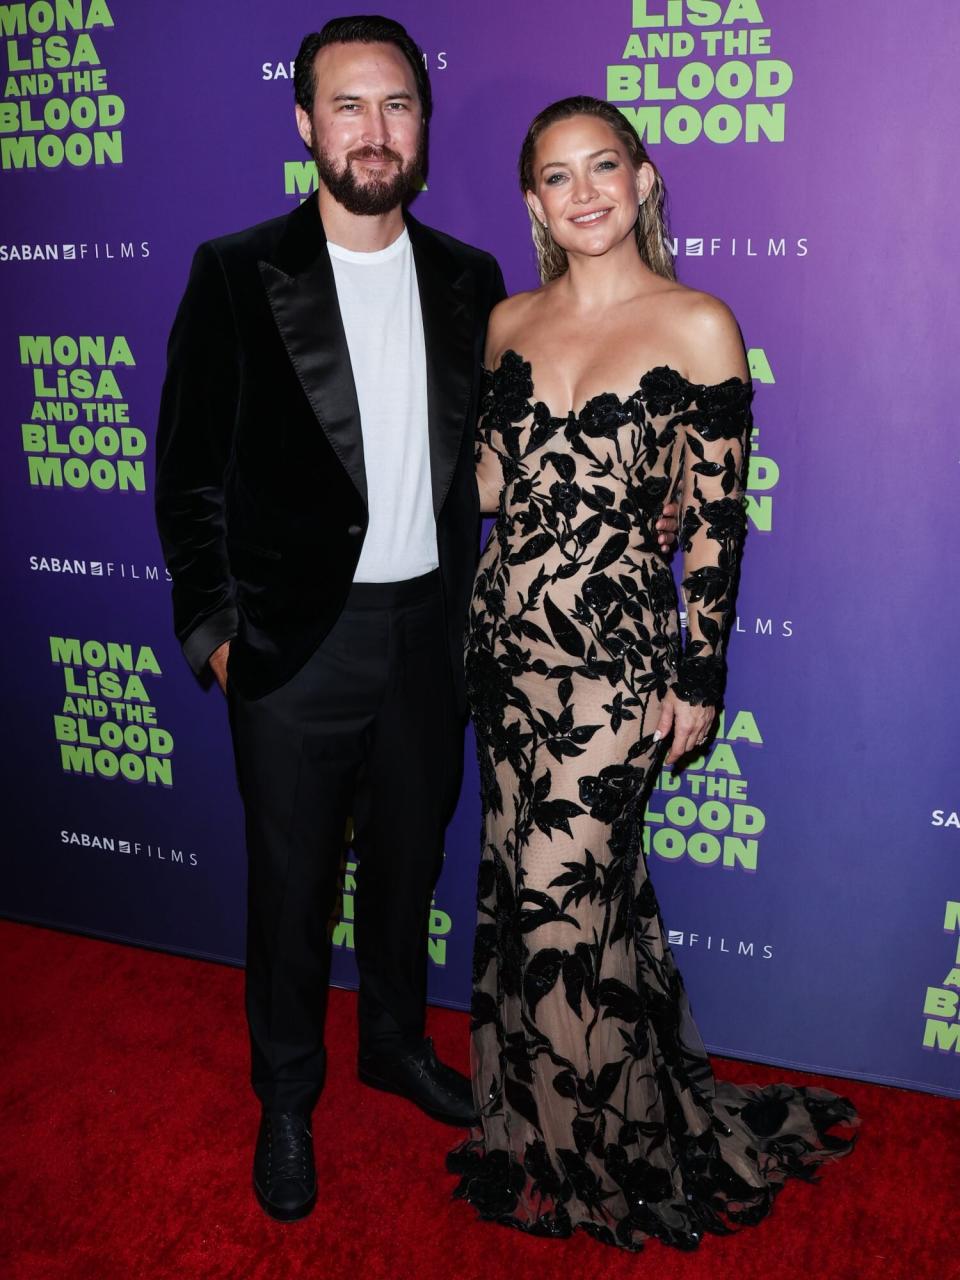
[673,378,753,707]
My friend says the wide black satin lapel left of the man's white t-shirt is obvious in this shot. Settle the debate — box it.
[259,201,367,502]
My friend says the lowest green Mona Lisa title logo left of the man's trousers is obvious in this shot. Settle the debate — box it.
[50,636,173,787]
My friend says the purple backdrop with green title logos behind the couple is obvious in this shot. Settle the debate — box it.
[0,0,960,1094]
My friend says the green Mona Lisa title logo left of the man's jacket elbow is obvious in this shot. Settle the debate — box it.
[19,334,147,493]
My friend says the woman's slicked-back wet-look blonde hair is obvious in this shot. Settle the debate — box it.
[520,95,676,284]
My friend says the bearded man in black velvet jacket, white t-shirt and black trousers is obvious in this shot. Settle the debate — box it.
[156,17,680,1220]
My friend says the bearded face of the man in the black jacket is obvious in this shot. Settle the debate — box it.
[297,44,424,215]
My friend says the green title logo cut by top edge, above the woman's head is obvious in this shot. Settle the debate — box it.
[604,0,794,143]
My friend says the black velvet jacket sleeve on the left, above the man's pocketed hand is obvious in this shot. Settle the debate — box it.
[156,244,241,673]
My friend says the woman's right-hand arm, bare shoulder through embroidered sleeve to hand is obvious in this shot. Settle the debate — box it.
[658,298,753,764]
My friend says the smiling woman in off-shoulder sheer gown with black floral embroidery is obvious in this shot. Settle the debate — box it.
[449,97,856,1249]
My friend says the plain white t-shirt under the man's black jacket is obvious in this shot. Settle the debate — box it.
[326,227,439,582]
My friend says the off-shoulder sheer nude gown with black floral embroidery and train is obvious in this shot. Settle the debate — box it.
[448,352,856,1249]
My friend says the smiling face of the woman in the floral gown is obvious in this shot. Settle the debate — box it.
[526,115,654,266]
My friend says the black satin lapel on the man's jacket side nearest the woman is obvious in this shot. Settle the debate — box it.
[407,216,474,516]
